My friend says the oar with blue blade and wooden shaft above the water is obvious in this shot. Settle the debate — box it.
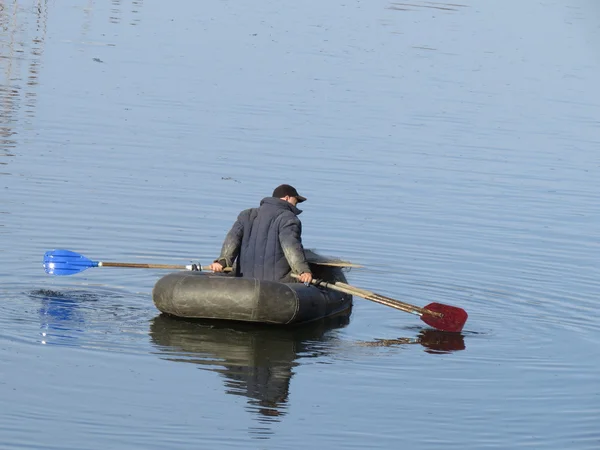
[44,250,210,275]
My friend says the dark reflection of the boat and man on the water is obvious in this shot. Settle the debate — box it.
[150,312,350,420]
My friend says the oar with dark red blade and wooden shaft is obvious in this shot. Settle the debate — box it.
[292,274,468,332]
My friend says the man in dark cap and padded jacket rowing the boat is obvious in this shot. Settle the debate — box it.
[210,184,313,284]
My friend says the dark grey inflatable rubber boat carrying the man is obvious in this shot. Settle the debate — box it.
[152,268,352,324]
